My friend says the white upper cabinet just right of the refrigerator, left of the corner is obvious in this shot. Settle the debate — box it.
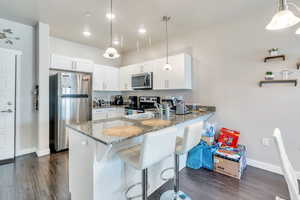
[93,65,120,91]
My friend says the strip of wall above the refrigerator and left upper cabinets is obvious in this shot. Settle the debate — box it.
[50,37,121,67]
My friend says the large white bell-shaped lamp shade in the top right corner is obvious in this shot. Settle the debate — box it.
[266,0,300,30]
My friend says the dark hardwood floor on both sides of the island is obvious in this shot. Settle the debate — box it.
[0,152,288,200]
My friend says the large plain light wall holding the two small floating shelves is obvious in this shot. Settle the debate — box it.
[122,10,300,171]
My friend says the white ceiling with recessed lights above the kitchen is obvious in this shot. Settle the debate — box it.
[0,0,275,52]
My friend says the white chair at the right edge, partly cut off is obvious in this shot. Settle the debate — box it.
[273,128,300,200]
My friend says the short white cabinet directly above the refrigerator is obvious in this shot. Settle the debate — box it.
[50,54,93,73]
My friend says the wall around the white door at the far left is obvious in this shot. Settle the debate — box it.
[0,19,37,155]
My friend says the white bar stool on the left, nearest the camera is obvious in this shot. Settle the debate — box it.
[117,127,177,200]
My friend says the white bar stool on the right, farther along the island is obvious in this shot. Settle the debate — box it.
[160,121,204,200]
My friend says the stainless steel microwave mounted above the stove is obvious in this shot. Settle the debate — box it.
[131,72,153,90]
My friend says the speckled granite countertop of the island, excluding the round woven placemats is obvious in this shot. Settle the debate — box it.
[67,110,215,145]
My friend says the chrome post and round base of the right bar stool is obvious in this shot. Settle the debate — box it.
[160,154,192,200]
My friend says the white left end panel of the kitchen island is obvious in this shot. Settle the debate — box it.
[69,130,96,200]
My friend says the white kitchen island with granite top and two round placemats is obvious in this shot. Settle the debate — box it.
[67,108,214,200]
